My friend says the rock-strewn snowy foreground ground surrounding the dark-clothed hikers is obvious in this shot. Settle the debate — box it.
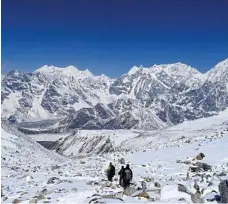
[1,111,228,204]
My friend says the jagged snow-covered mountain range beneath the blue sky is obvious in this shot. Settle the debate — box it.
[2,59,228,129]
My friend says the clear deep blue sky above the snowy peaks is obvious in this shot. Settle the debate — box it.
[2,0,228,77]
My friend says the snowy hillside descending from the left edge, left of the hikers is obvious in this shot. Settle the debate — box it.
[1,124,63,177]
